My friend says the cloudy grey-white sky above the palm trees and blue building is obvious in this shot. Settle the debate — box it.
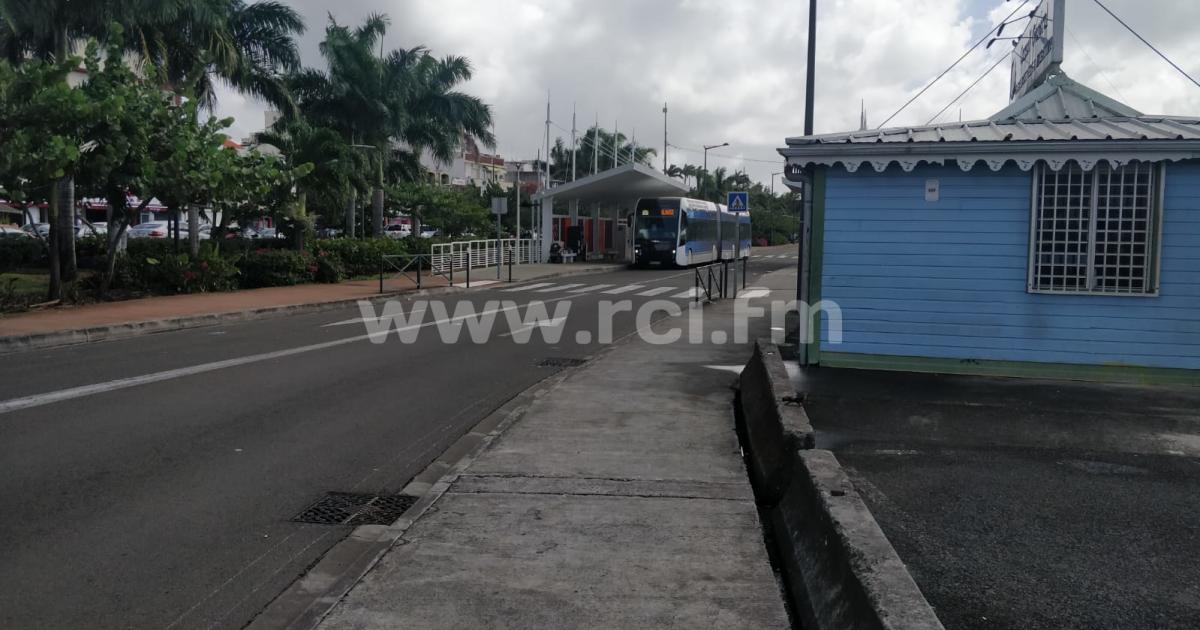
[217,0,1200,182]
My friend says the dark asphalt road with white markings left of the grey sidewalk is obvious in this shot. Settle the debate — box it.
[0,247,796,629]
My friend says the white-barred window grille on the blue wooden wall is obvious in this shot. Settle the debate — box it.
[1030,162,1160,295]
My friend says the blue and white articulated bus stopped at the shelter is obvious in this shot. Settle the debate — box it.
[632,197,750,266]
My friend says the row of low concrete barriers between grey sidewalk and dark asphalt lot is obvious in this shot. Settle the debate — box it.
[738,340,943,630]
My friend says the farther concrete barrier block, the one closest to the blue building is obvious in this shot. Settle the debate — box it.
[738,340,815,506]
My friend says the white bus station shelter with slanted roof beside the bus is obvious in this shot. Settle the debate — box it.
[533,163,688,262]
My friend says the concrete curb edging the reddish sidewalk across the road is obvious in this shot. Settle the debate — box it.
[0,287,463,355]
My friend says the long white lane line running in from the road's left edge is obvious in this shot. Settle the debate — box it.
[0,300,552,415]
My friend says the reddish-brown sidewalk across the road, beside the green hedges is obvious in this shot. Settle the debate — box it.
[0,264,620,352]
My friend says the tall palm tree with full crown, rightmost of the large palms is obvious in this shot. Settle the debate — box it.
[290,14,496,234]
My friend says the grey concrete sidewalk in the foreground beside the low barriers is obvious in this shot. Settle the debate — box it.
[294,286,788,630]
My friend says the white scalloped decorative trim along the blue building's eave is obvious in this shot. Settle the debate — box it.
[787,151,1195,173]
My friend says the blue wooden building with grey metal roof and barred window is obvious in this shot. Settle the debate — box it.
[780,72,1200,384]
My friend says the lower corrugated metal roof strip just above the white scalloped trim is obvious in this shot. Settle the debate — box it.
[787,116,1200,146]
